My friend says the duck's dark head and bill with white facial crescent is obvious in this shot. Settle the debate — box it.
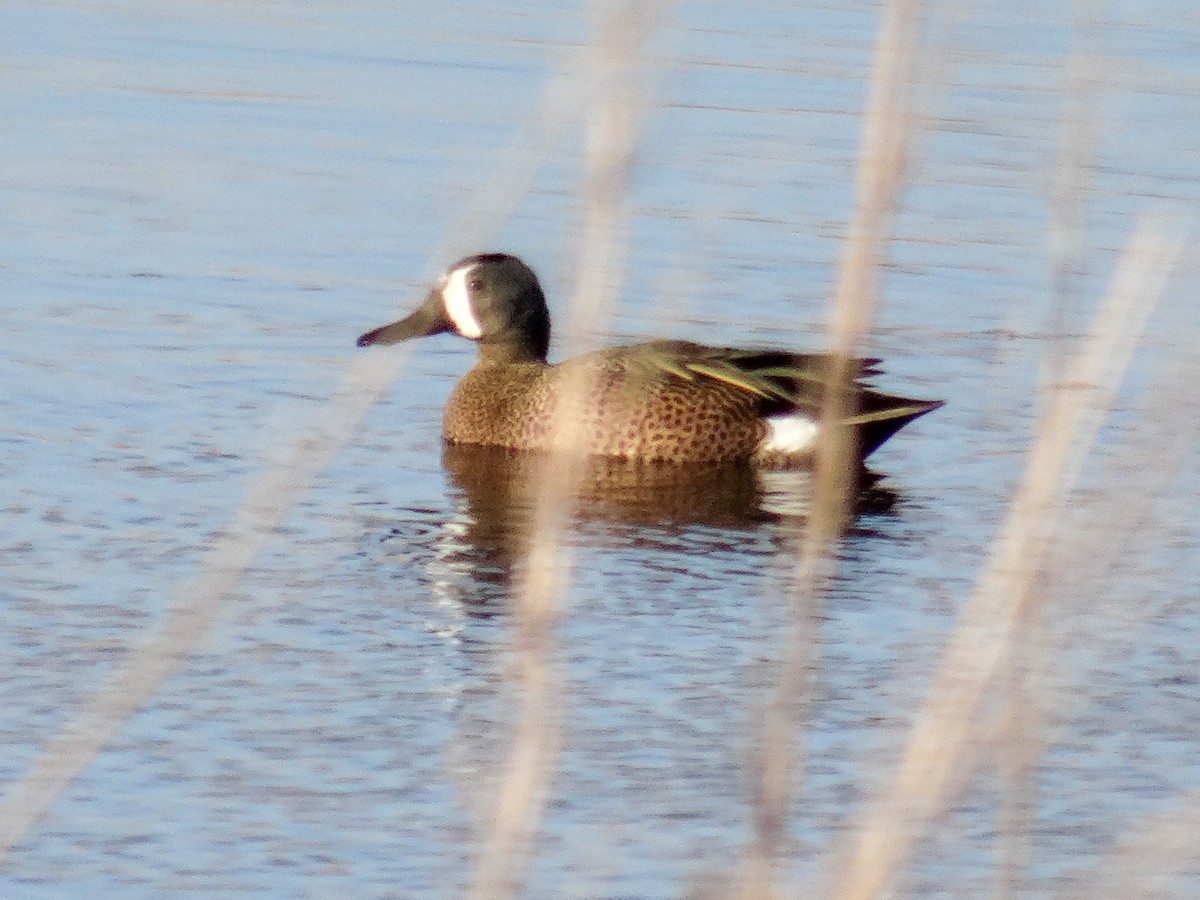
[358,253,550,362]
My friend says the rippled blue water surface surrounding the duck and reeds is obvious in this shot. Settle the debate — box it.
[0,0,1200,898]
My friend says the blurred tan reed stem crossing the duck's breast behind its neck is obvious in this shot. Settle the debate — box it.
[468,0,653,900]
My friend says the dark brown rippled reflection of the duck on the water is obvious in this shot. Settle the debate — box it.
[362,445,896,630]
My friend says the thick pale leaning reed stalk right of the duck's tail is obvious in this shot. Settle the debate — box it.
[836,218,1182,899]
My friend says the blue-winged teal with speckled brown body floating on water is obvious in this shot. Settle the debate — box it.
[358,253,942,466]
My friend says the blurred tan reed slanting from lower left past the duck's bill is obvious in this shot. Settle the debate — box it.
[0,40,589,868]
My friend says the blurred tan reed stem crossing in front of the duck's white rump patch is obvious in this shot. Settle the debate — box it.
[742,0,922,900]
